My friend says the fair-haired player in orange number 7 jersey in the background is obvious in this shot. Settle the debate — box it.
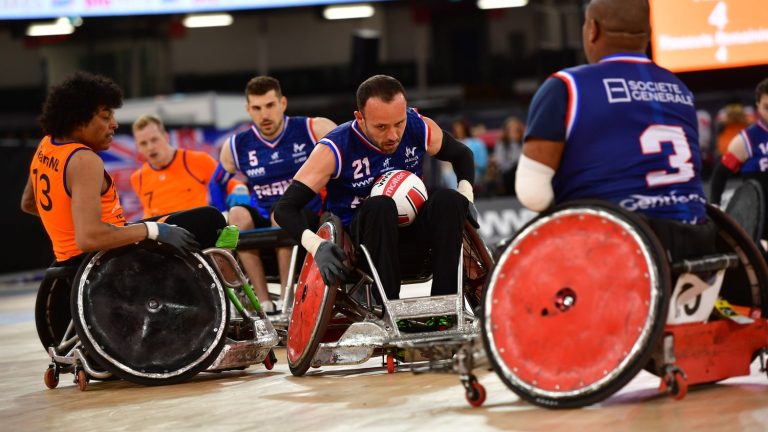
[131,114,242,218]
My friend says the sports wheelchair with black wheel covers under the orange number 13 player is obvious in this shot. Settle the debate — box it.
[35,227,278,390]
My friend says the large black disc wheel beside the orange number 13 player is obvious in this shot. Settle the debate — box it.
[71,242,229,385]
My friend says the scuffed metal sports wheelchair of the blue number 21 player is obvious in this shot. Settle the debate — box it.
[286,215,493,394]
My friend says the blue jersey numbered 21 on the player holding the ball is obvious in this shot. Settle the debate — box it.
[318,108,430,226]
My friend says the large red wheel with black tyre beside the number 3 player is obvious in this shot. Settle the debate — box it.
[483,202,670,407]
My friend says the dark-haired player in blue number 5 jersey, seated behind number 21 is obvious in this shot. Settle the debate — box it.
[210,76,336,313]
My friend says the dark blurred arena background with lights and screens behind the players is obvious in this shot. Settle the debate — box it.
[0,0,768,274]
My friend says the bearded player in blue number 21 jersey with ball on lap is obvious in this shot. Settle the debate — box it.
[275,75,477,299]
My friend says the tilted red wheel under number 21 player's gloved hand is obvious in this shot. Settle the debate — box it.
[285,216,352,376]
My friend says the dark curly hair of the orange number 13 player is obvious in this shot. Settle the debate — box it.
[40,72,123,137]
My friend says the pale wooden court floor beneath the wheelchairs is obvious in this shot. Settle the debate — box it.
[0,287,768,432]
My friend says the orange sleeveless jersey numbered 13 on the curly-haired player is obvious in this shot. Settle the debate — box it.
[29,136,125,262]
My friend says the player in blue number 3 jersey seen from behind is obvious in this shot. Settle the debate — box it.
[515,0,715,259]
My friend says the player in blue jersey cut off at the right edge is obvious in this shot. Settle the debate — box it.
[710,78,768,240]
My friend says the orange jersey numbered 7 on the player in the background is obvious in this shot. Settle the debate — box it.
[131,149,222,218]
